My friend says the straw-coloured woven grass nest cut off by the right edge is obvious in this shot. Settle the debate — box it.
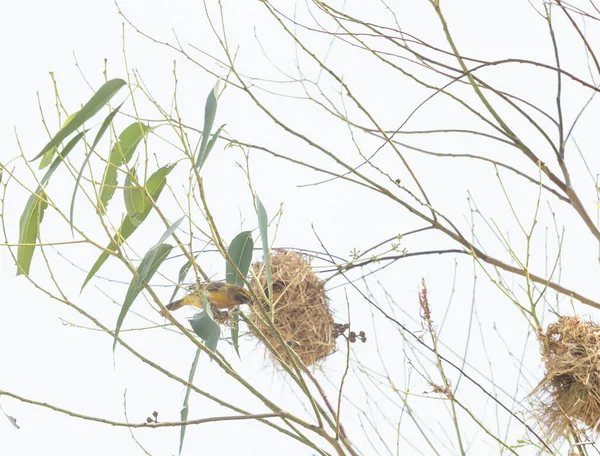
[532,317,600,438]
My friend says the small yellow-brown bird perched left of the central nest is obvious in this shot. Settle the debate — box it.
[166,282,250,311]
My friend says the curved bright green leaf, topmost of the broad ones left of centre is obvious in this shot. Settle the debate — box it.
[98,122,150,214]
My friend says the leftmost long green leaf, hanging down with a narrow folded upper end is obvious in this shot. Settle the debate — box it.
[17,132,84,275]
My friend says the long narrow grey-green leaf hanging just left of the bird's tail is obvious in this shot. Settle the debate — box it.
[113,217,183,351]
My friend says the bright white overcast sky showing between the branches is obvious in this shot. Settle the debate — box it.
[0,0,599,456]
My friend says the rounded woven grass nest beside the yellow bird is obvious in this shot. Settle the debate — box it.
[249,249,335,366]
